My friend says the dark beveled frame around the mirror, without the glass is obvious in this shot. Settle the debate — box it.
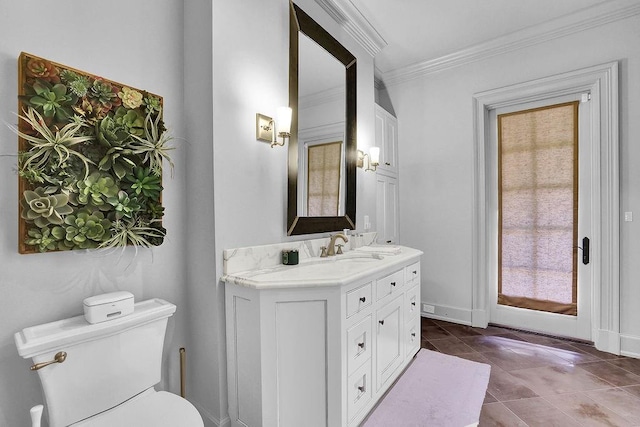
[287,3,358,236]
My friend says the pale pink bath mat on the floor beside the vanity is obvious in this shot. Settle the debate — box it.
[362,348,491,427]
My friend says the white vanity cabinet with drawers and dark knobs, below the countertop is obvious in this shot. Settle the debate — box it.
[223,248,420,427]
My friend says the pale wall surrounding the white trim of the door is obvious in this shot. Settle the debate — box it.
[387,16,640,354]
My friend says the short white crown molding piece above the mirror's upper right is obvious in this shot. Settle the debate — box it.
[315,0,387,56]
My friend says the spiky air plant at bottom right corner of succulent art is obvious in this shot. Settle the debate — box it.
[100,217,166,250]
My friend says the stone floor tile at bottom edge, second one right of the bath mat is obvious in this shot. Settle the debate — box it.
[504,397,580,427]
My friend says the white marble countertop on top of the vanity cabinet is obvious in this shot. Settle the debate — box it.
[222,246,422,289]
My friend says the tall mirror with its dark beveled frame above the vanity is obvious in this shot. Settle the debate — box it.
[287,3,357,235]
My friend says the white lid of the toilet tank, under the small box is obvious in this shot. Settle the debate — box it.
[14,298,176,359]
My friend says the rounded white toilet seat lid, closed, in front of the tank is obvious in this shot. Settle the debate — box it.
[72,388,204,427]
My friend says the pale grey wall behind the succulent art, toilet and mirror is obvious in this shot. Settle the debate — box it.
[0,0,375,426]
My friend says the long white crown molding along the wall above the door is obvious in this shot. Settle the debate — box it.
[380,0,640,87]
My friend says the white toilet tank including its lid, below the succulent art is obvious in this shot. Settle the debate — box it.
[14,299,176,427]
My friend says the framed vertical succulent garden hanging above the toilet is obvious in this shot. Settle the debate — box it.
[12,53,173,253]
